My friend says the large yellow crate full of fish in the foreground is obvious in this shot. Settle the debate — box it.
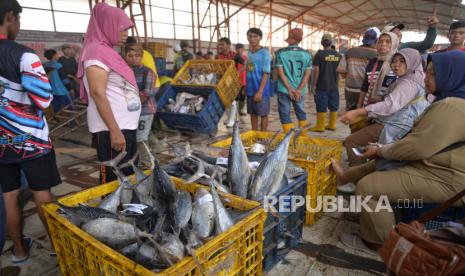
[44,177,266,276]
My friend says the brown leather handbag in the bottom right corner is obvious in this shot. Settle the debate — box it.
[378,189,465,276]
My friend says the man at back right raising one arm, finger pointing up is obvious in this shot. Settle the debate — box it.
[381,8,439,54]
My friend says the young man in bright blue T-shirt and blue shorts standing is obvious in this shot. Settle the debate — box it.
[246,28,271,131]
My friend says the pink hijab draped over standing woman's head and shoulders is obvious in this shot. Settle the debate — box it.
[77,3,137,101]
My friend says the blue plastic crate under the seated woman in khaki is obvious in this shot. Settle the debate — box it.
[394,203,465,230]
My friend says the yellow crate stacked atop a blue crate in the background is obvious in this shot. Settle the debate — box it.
[171,60,241,108]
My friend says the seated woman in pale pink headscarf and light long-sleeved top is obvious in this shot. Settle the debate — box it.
[341,49,430,165]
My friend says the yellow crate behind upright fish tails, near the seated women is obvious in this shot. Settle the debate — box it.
[212,131,342,225]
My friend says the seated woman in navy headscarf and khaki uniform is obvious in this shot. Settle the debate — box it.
[339,51,465,254]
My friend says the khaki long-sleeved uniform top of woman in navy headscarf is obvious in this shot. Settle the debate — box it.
[381,98,465,186]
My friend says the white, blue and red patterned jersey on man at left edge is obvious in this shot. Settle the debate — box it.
[0,38,53,164]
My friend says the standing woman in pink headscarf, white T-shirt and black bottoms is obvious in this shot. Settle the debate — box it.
[78,3,141,183]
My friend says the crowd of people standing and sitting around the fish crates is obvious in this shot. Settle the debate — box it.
[0,0,465,272]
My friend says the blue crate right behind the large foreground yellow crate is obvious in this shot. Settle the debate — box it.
[263,173,307,271]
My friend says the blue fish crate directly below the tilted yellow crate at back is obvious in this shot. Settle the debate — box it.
[157,85,224,134]
